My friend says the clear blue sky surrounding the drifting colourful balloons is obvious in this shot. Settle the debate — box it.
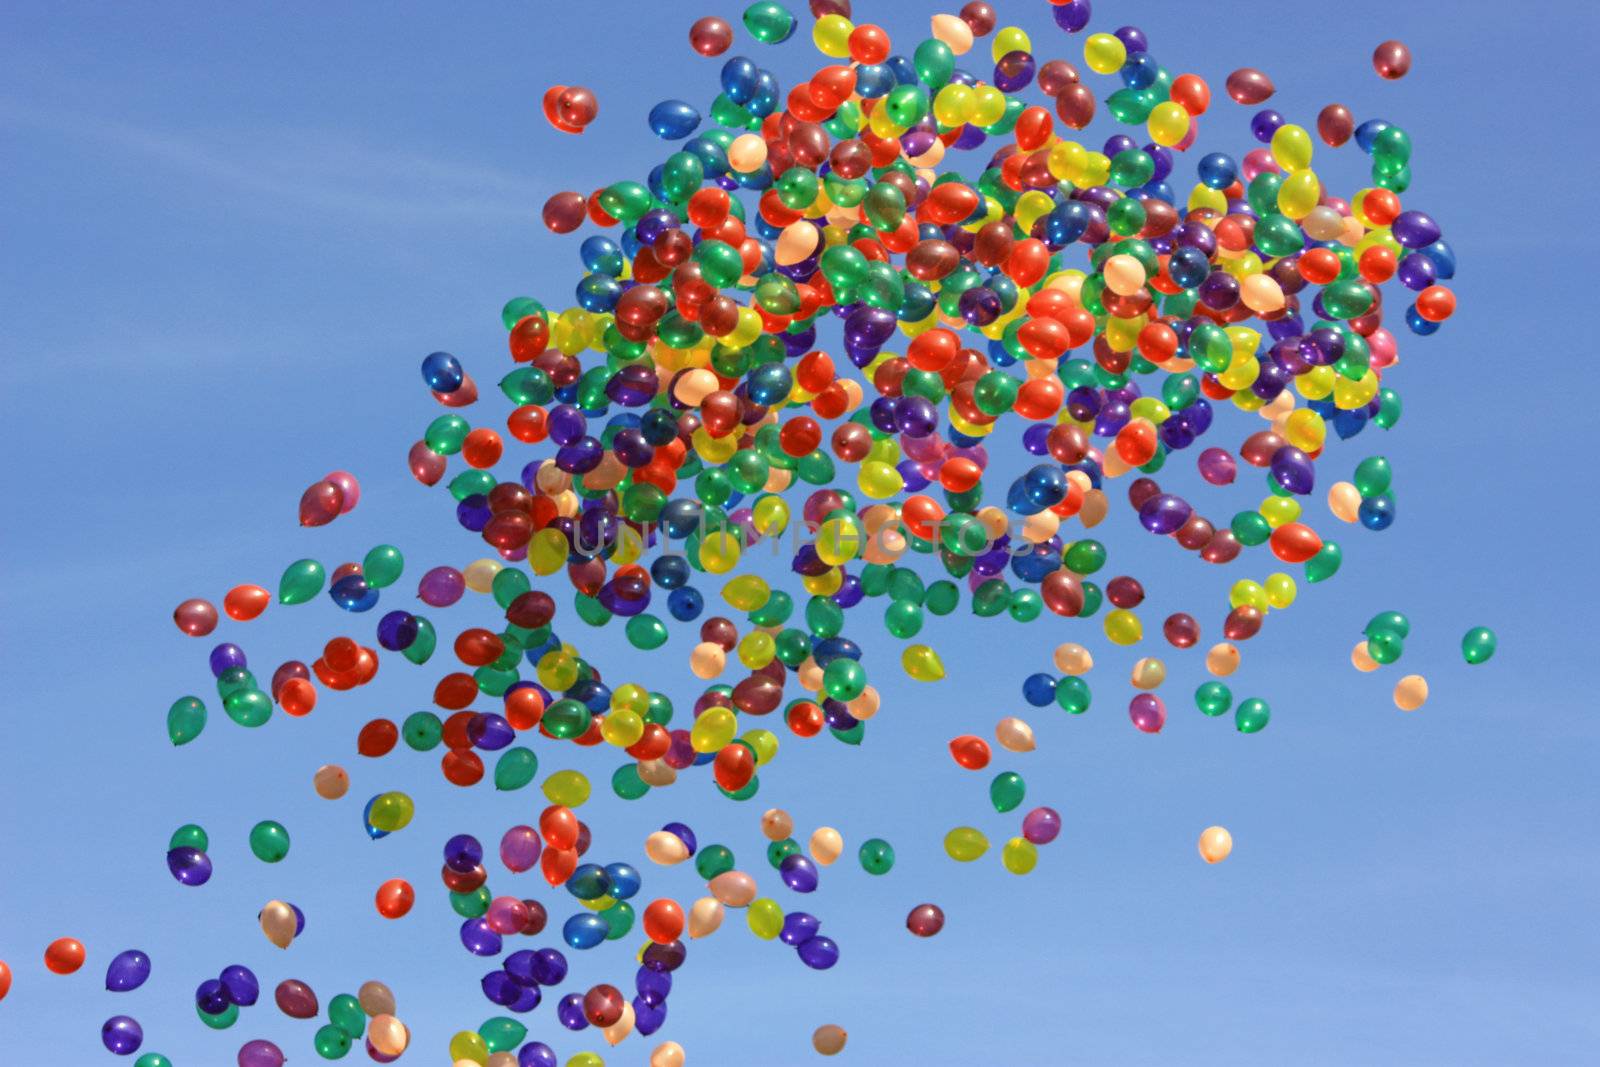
[0,2,1600,1067]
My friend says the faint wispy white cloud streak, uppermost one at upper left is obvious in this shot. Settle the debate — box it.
[0,99,550,222]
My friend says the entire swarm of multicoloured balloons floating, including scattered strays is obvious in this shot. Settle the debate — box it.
[12,0,1496,1067]
